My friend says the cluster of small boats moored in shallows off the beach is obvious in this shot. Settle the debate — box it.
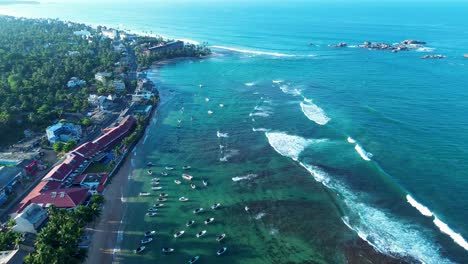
[134,162,227,263]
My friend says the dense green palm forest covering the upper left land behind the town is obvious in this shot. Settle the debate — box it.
[0,16,120,145]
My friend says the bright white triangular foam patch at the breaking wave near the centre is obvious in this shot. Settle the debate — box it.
[265,132,327,161]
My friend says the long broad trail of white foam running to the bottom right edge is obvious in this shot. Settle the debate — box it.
[299,162,451,263]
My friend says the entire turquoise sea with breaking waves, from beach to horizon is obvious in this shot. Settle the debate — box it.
[0,1,468,263]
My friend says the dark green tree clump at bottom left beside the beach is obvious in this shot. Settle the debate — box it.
[24,194,104,264]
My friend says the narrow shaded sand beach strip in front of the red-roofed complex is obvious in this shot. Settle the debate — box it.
[85,155,131,264]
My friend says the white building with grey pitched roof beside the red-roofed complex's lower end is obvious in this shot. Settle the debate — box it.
[12,203,48,234]
